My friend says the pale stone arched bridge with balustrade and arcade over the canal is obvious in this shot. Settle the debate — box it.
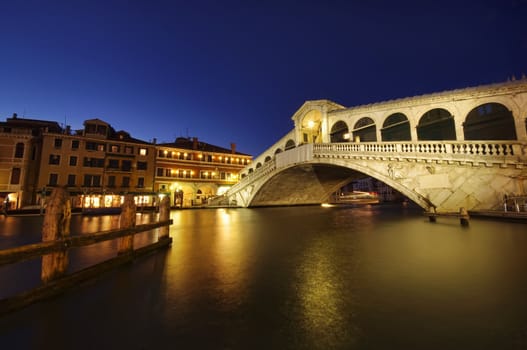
[219,78,527,213]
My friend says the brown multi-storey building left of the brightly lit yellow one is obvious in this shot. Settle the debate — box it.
[36,119,156,208]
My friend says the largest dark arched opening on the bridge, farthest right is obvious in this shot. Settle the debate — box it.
[463,103,516,140]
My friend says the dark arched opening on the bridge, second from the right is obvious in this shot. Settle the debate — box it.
[417,108,456,141]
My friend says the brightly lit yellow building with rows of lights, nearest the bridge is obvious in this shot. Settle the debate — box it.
[154,137,252,207]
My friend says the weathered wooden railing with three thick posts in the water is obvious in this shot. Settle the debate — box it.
[0,187,172,315]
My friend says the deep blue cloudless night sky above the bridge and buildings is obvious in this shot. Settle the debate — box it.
[0,0,527,156]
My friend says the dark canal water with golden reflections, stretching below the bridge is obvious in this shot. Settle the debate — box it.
[0,205,527,349]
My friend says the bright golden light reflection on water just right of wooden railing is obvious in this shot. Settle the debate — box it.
[168,209,249,309]
